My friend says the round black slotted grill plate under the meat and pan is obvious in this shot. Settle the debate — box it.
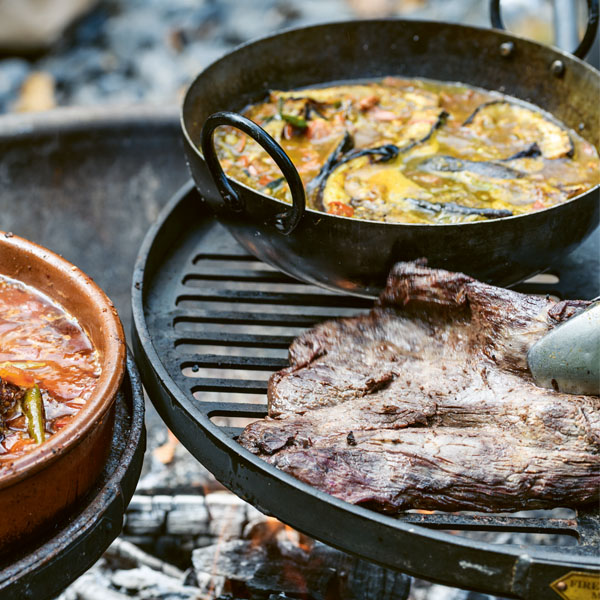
[132,184,600,598]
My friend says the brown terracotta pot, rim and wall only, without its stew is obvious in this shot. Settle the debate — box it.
[0,232,126,553]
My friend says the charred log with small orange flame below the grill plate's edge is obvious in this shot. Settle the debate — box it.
[192,519,410,600]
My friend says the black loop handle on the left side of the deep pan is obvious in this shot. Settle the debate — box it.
[200,112,306,235]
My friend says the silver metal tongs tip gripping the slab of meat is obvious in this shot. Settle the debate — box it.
[527,299,600,395]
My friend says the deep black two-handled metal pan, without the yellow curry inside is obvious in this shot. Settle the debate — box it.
[182,0,600,296]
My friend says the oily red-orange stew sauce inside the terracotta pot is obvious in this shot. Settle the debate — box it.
[0,276,101,460]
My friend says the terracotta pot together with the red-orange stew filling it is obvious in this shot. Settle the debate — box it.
[0,232,126,556]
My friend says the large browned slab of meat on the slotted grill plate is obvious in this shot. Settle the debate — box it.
[239,263,600,513]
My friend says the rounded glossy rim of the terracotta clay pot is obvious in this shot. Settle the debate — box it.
[0,231,126,490]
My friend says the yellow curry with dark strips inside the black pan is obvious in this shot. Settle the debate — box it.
[215,77,600,224]
